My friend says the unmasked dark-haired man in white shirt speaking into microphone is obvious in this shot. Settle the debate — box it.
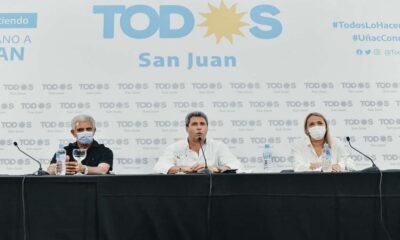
[154,112,241,174]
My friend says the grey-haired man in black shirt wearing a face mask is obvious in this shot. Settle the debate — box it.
[47,115,113,175]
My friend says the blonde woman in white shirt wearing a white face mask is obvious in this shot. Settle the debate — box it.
[292,113,354,172]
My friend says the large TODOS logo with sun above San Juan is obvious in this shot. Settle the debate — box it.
[93,1,282,43]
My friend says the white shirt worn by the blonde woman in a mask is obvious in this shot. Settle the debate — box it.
[292,138,354,172]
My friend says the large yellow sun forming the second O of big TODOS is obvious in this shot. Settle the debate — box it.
[198,1,249,44]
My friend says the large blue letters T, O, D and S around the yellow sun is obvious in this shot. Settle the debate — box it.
[94,4,282,41]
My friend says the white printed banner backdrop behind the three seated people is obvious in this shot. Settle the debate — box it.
[0,0,400,174]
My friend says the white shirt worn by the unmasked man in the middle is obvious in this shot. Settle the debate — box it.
[154,138,241,174]
